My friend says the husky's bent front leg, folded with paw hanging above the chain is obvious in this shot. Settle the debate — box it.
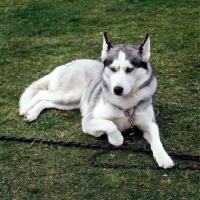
[82,117,124,146]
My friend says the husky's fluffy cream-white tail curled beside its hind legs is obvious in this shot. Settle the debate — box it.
[19,75,49,110]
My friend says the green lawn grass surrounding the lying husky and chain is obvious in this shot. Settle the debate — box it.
[0,0,200,200]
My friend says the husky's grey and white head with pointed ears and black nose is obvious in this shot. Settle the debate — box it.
[101,33,150,96]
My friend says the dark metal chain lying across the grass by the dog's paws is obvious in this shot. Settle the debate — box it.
[0,135,200,170]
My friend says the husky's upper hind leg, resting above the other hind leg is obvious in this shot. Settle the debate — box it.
[20,90,82,115]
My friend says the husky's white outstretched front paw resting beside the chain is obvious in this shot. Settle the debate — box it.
[153,150,174,169]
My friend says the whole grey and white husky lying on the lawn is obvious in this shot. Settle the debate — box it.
[19,32,174,169]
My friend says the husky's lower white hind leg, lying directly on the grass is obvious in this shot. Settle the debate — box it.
[25,100,79,122]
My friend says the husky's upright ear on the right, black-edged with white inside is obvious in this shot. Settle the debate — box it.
[139,33,151,63]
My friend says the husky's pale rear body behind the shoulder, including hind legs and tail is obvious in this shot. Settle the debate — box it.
[19,59,103,121]
